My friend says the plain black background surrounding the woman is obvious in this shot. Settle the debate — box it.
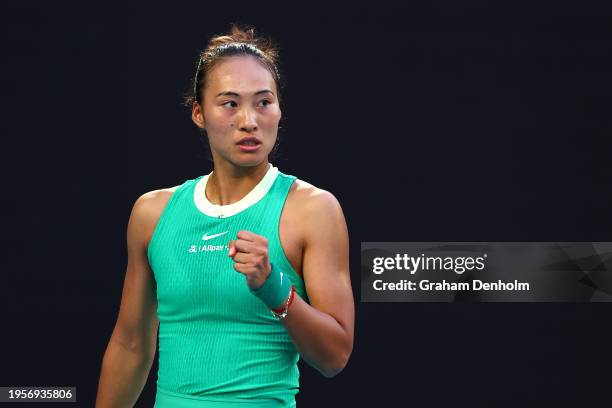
[0,1,612,407]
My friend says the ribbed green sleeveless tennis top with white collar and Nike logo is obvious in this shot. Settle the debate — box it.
[147,165,308,408]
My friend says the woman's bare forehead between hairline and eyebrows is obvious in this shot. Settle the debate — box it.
[206,55,276,95]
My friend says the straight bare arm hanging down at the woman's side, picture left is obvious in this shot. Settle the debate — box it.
[96,193,159,408]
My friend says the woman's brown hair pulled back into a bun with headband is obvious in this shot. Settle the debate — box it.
[184,25,281,108]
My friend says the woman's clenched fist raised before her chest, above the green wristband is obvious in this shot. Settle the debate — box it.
[227,230,272,290]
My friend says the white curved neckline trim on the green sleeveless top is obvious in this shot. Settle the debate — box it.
[193,163,278,218]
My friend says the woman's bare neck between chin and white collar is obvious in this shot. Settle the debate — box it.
[206,160,270,205]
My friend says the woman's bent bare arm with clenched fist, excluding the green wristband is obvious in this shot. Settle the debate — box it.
[228,188,355,377]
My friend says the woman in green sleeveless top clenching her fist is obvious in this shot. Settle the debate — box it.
[97,27,354,408]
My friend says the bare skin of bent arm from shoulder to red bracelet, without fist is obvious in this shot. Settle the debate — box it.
[283,190,355,377]
